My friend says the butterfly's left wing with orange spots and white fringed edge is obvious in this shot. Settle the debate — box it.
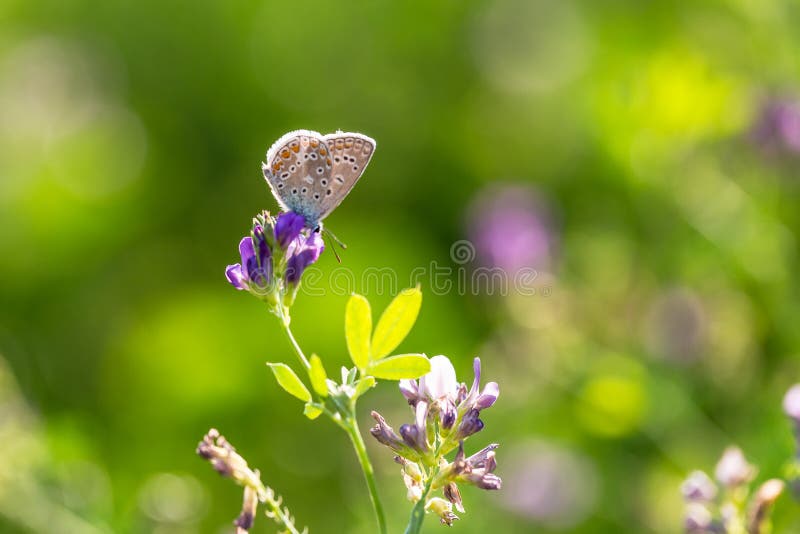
[261,130,333,228]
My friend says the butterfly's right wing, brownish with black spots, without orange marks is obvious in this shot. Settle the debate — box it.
[315,132,375,219]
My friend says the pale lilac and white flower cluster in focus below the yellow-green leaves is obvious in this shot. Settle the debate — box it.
[370,356,502,525]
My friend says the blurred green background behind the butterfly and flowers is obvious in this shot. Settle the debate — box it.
[0,0,800,533]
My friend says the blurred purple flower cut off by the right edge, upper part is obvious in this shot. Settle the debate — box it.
[752,99,800,154]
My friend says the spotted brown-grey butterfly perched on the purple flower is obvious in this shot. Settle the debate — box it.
[261,130,375,231]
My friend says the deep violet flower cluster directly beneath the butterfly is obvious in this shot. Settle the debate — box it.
[225,211,325,302]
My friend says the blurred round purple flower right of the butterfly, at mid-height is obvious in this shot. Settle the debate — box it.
[467,186,555,274]
